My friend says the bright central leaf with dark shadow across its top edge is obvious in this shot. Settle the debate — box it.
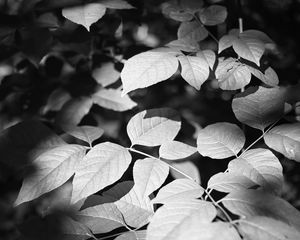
[127,108,181,146]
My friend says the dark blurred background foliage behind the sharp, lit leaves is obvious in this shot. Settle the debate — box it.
[0,0,300,239]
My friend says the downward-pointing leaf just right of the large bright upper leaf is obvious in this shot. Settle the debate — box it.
[178,55,209,90]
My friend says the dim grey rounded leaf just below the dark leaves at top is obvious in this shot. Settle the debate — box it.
[177,20,208,42]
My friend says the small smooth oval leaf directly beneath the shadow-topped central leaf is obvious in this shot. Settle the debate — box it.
[159,141,197,160]
